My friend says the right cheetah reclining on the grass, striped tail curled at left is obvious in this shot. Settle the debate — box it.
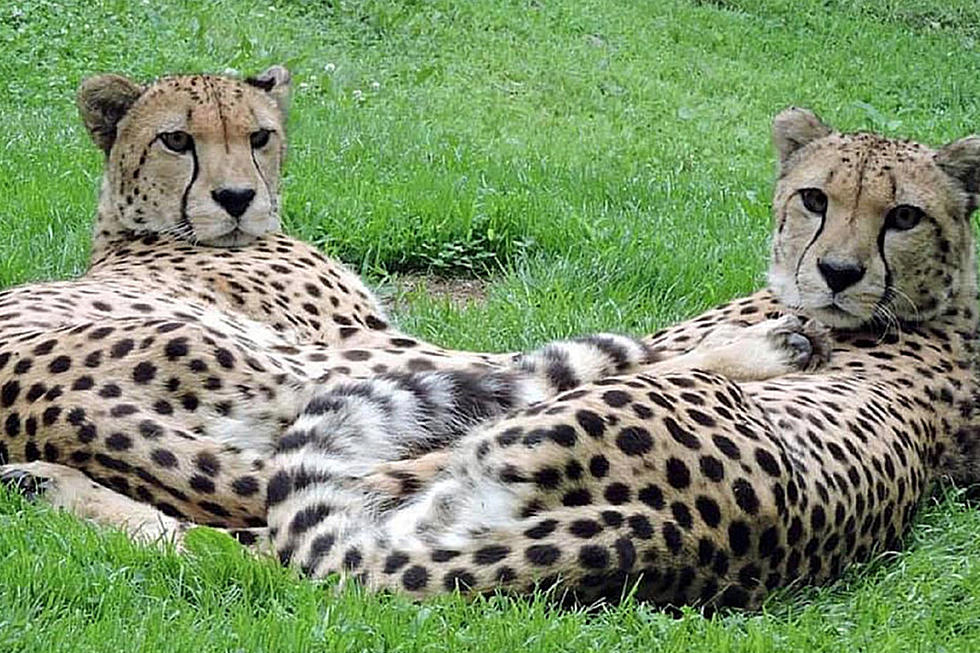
[5,109,980,606]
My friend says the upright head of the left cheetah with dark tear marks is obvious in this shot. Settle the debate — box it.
[78,66,289,249]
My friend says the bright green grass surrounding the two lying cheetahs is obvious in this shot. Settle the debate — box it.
[0,0,980,652]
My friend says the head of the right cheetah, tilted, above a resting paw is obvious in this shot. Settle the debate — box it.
[769,108,980,329]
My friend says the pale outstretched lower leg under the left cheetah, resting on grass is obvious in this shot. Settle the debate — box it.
[0,461,271,552]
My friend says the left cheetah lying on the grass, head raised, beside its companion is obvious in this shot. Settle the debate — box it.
[0,66,520,526]
